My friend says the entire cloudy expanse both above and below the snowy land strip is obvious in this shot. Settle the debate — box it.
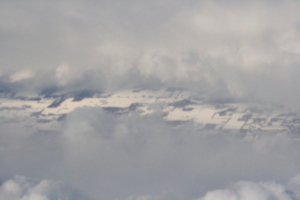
[0,0,300,200]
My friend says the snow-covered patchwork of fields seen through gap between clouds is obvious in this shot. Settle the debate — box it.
[0,89,300,132]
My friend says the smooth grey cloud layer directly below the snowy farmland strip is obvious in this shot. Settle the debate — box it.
[0,107,300,200]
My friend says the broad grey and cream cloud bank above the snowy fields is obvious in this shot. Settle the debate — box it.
[0,0,300,106]
